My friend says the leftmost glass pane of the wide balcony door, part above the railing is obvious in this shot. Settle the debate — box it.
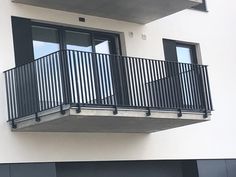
[32,26,60,59]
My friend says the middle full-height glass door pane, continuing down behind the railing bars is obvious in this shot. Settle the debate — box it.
[65,31,94,104]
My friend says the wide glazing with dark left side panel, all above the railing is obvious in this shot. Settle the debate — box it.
[12,17,121,66]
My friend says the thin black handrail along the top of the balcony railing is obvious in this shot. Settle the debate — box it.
[3,49,208,73]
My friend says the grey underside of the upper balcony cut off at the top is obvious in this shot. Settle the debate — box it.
[12,0,202,24]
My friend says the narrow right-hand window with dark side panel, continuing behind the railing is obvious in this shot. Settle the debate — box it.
[163,39,203,107]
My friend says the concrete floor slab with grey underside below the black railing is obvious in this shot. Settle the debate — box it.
[13,106,210,133]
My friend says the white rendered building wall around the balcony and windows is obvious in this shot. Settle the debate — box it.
[0,0,236,163]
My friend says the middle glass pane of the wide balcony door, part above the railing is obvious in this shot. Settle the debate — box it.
[66,31,92,52]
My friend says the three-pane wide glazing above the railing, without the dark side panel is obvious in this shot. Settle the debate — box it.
[31,22,118,59]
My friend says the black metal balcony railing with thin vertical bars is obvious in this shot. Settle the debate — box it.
[5,50,212,125]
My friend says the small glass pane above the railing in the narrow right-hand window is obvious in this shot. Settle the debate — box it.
[176,46,192,63]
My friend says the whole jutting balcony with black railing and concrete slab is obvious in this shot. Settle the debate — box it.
[5,50,213,133]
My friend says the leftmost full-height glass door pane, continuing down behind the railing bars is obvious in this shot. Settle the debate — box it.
[32,26,62,110]
